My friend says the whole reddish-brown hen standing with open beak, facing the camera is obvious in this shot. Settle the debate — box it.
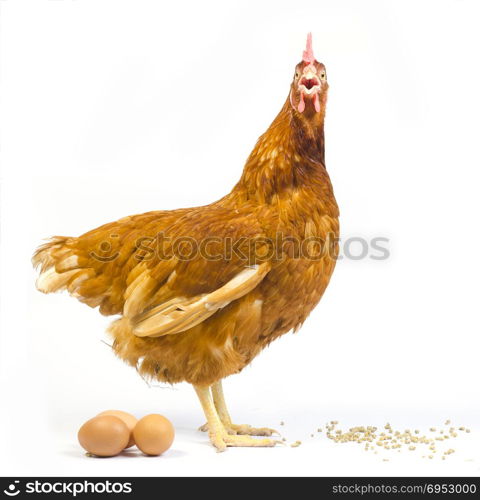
[33,35,339,451]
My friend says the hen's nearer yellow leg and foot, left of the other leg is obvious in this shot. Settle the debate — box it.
[194,385,277,452]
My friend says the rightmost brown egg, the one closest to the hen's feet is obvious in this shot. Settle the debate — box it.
[133,414,175,455]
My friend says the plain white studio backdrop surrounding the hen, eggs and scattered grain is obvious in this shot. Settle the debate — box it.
[0,0,480,476]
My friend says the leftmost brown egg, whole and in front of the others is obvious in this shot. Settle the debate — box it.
[78,415,130,457]
